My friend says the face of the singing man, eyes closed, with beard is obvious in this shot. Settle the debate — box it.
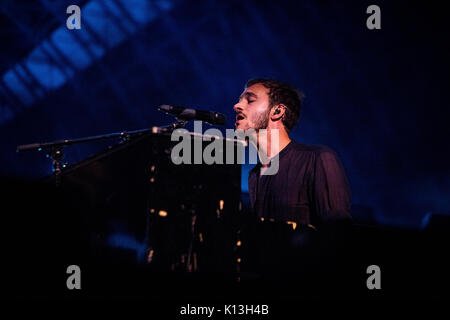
[233,83,270,131]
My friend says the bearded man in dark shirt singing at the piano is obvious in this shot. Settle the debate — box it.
[234,79,350,229]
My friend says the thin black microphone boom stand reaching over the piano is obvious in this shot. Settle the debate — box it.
[16,119,188,187]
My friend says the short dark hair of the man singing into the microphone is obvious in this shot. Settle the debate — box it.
[245,78,303,133]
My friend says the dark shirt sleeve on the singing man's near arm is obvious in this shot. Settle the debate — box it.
[311,149,351,223]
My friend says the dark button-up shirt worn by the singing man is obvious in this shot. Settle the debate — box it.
[248,140,351,226]
